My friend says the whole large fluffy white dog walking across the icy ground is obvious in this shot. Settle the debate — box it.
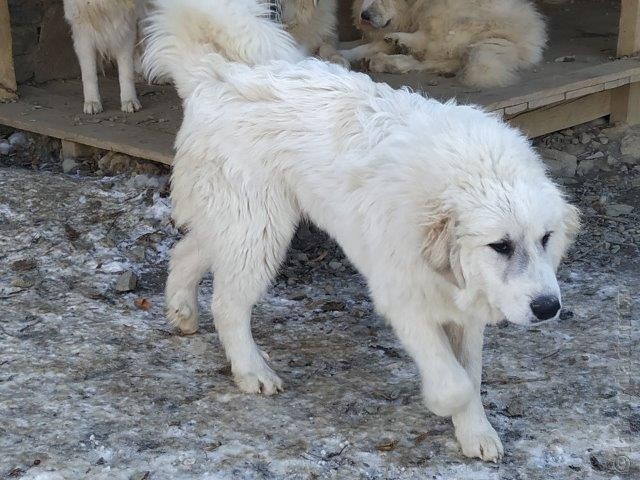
[143,0,578,461]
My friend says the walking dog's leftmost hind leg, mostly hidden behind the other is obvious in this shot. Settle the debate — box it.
[165,232,211,334]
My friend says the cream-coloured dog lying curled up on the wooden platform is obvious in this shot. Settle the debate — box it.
[341,0,547,88]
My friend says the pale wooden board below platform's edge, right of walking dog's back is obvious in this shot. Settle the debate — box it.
[507,90,611,137]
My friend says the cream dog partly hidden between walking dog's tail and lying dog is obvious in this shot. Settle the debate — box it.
[270,0,349,67]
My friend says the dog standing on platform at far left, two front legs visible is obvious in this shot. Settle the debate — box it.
[64,0,145,114]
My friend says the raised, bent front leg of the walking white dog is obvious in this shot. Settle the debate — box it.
[387,309,475,417]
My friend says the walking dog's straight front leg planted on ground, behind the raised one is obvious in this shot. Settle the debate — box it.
[447,320,504,462]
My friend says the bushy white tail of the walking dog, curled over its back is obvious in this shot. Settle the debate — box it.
[142,0,302,98]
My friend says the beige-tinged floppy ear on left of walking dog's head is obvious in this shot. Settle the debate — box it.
[422,207,466,288]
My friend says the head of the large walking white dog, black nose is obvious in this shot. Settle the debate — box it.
[423,145,579,325]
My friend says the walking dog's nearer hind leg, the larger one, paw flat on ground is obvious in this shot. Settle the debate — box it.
[212,193,299,395]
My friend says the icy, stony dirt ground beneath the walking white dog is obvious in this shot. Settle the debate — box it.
[0,121,640,480]
